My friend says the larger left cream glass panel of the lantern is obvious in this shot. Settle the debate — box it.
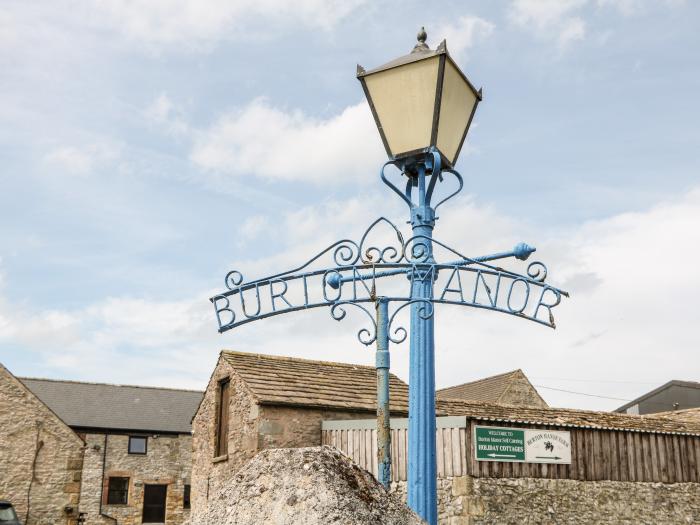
[365,56,439,157]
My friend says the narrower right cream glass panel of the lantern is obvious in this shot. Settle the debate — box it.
[435,59,477,165]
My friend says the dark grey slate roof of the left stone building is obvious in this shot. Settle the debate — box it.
[18,377,203,433]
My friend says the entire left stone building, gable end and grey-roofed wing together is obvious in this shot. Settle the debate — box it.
[0,365,202,525]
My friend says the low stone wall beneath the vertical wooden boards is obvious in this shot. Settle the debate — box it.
[392,476,700,525]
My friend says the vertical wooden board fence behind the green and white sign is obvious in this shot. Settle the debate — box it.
[322,416,700,483]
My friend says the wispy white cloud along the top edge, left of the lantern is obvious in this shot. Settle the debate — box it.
[95,0,364,47]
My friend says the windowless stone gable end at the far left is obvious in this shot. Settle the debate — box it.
[0,365,84,525]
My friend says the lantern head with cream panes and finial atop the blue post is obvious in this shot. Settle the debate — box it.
[357,28,481,167]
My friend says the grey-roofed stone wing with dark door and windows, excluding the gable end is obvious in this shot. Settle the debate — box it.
[20,378,202,525]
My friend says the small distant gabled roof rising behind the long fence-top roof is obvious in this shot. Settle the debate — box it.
[437,369,548,408]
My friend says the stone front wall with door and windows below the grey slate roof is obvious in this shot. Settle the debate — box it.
[80,434,192,525]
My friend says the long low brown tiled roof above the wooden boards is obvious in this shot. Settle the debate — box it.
[437,399,700,435]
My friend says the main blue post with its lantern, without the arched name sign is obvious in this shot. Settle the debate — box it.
[357,28,481,524]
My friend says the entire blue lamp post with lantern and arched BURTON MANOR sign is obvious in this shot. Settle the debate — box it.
[210,25,568,525]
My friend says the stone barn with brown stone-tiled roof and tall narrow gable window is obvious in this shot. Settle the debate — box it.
[192,351,408,524]
